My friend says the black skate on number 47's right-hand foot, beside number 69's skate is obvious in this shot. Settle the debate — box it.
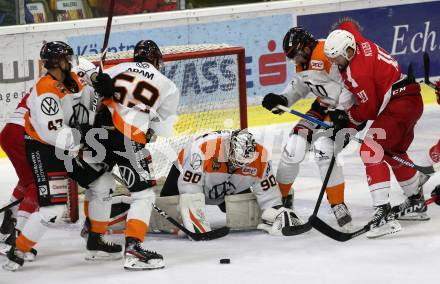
[86,232,122,260]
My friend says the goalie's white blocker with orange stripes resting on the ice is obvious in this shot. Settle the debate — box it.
[180,193,211,233]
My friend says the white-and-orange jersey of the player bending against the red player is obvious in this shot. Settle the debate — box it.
[281,40,354,110]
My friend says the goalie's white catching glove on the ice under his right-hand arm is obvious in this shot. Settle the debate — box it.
[257,207,304,236]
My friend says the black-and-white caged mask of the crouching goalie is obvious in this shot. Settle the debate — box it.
[229,130,257,168]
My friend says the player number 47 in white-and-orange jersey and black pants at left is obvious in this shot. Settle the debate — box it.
[3,41,122,271]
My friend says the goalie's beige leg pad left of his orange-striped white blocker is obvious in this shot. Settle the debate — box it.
[149,195,182,233]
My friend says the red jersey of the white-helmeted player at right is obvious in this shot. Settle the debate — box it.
[339,22,403,124]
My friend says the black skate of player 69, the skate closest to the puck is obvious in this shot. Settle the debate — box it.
[124,237,165,270]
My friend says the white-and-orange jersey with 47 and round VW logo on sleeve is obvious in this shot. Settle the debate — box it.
[25,72,95,150]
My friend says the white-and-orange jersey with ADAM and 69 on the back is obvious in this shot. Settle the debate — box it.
[103,62,180,144]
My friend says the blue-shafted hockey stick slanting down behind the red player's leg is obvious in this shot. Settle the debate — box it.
[277,105,440,175]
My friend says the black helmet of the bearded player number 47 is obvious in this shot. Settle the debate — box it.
[40,41,73,69]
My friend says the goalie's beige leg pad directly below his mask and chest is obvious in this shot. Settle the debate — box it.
[225,193,261,230]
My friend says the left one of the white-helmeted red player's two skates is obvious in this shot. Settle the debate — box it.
[365,203,402,239]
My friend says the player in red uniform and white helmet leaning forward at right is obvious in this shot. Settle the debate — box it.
[324,21,429,238]
